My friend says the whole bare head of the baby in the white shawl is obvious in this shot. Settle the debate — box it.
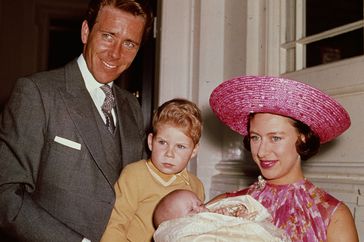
[153,189,207,228]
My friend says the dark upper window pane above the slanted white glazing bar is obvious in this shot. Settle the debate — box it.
[306,0,363,36]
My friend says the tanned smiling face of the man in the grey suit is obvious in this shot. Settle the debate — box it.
[81,6,145,84]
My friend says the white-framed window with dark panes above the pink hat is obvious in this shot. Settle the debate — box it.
[281,0,364,73]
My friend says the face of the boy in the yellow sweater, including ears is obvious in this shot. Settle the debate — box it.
[148,124,198,174]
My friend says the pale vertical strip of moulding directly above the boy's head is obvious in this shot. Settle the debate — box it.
[156,0,196,105]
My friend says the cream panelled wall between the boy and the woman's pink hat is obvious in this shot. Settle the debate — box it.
[158,0,245,198]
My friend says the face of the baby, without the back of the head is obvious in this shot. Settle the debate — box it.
[175,193,207,217]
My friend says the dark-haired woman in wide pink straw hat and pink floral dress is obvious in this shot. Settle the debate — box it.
[210,76,359,242]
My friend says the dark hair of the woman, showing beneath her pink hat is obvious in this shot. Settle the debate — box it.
[243,113,320,160]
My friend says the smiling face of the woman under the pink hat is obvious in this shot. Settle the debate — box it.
[249,113,303,184]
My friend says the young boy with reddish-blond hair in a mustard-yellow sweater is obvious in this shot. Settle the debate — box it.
[101,99,205,242]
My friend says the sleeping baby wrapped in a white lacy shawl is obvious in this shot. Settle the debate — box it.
[153,190,290,242]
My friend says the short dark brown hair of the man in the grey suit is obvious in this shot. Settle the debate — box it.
[85,0,153,41]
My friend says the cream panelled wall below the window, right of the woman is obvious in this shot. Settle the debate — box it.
[286,56,364,240]
